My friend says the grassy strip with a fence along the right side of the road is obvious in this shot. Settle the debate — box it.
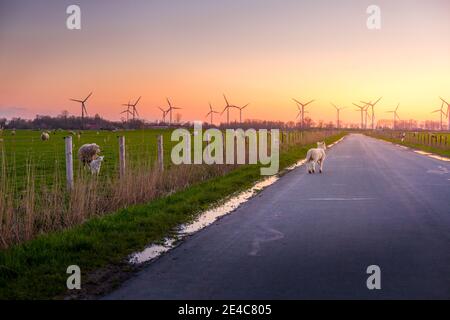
[366,131,450,158]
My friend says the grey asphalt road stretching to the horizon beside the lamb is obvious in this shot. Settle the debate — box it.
[105,135,450,299]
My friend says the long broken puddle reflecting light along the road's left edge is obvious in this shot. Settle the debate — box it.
[128,138,344,264]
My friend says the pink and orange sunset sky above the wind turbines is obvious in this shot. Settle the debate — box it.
[0,0,450,123]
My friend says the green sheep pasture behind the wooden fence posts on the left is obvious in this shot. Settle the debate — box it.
[0,129,174,190]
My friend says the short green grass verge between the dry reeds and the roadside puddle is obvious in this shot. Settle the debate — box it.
[0,134,344,299]
